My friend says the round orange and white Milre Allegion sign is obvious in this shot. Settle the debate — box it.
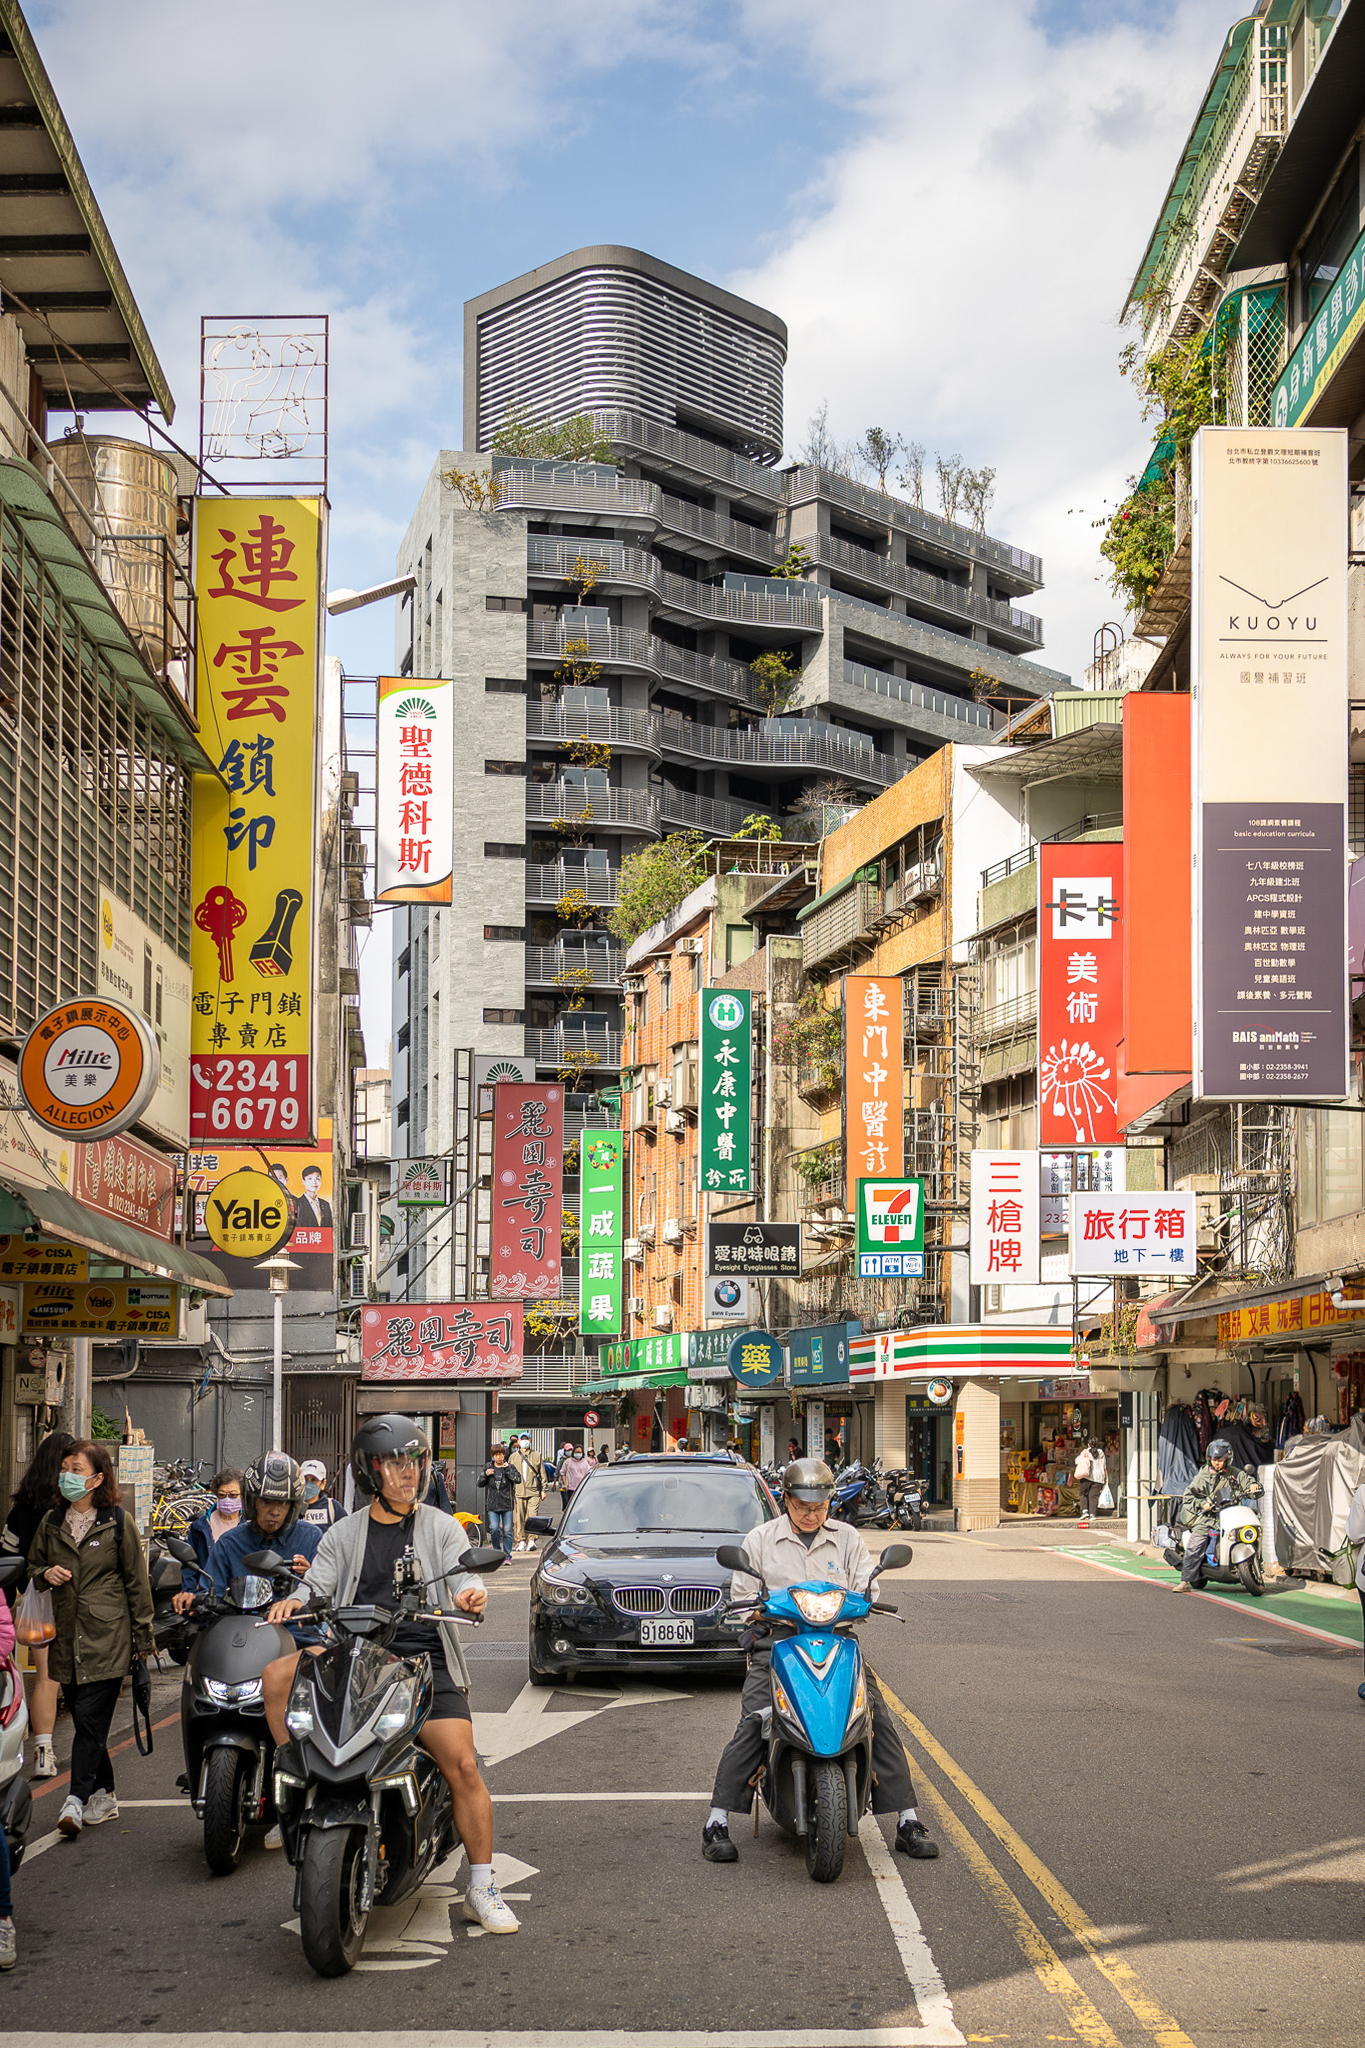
[18,997,162,1139]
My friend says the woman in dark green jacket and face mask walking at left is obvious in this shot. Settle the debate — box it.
[29,1442,153,1835]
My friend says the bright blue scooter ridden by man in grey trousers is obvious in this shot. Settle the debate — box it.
[716,1542,913,1884]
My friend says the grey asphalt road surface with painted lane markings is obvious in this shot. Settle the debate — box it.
[0,1530,1365,2048]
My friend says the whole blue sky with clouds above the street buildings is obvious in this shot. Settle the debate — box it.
[29,0,1240,1048]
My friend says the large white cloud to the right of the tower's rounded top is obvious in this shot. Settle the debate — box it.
[731,0,1230,680]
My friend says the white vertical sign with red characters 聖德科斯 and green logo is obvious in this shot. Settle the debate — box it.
[375,676,454,903]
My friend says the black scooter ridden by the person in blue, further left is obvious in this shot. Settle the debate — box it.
[168,1536,299,1878]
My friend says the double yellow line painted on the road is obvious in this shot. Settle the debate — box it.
[878,1677,1195,2048]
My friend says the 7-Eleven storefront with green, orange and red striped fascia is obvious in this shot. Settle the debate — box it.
[849,1323,1074,1530]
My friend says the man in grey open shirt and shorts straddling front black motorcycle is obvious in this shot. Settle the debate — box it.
[264,1415,520,1933]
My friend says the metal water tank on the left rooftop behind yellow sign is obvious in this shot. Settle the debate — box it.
[49,434,176,670]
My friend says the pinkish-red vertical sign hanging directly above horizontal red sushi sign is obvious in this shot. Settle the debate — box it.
[489,1081,565,1300]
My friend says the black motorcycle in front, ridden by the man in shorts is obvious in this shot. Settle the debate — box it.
[270,1550,505,1976]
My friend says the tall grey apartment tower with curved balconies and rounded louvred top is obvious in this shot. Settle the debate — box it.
[393,248,1066,1296]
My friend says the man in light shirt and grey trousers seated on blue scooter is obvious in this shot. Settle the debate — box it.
[702,1458,939,1864]
